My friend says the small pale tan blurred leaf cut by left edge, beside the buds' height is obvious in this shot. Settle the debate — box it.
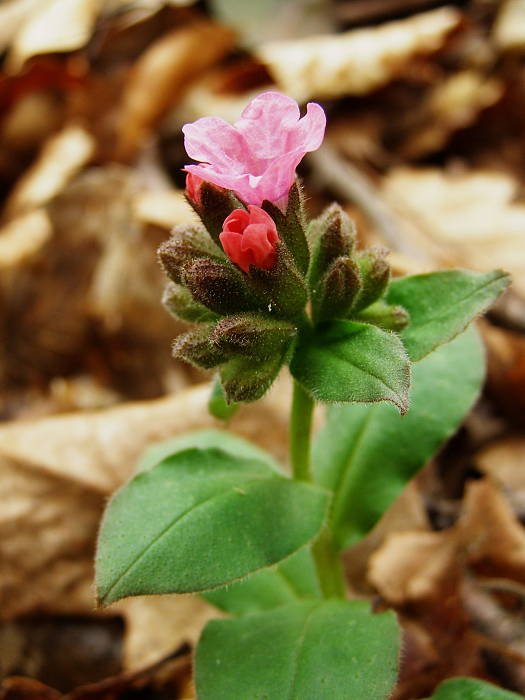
[0,209,53,270]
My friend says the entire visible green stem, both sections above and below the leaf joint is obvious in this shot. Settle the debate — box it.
[290,381,345,598]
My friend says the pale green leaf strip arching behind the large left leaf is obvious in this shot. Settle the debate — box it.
[137,428,281,473]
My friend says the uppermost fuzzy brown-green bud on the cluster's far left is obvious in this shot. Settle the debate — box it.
[158,226,224,284]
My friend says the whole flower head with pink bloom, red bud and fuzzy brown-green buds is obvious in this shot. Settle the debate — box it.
[159,92,407,402]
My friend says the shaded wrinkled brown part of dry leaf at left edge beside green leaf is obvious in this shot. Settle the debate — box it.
[0,460,104,619]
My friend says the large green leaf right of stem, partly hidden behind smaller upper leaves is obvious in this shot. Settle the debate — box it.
[313,328,484,549]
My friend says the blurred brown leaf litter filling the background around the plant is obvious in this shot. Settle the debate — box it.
[0,0,525,700]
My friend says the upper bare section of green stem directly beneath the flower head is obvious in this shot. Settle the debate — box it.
[290,381,314,481]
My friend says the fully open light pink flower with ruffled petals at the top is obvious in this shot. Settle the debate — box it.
[182,92,326,206]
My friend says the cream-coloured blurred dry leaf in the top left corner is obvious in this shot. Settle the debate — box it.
[8,0,103,72]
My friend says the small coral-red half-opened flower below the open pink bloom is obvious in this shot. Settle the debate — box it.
[219,204,279,272]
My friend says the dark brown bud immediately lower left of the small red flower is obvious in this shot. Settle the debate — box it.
[182,258,261,316]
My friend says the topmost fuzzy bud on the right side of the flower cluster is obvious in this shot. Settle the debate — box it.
[308,204,355,289]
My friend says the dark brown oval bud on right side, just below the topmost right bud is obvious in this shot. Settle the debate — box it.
[312,257,361,321]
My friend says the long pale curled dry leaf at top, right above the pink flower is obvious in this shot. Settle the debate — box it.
[256,7,461,102]
